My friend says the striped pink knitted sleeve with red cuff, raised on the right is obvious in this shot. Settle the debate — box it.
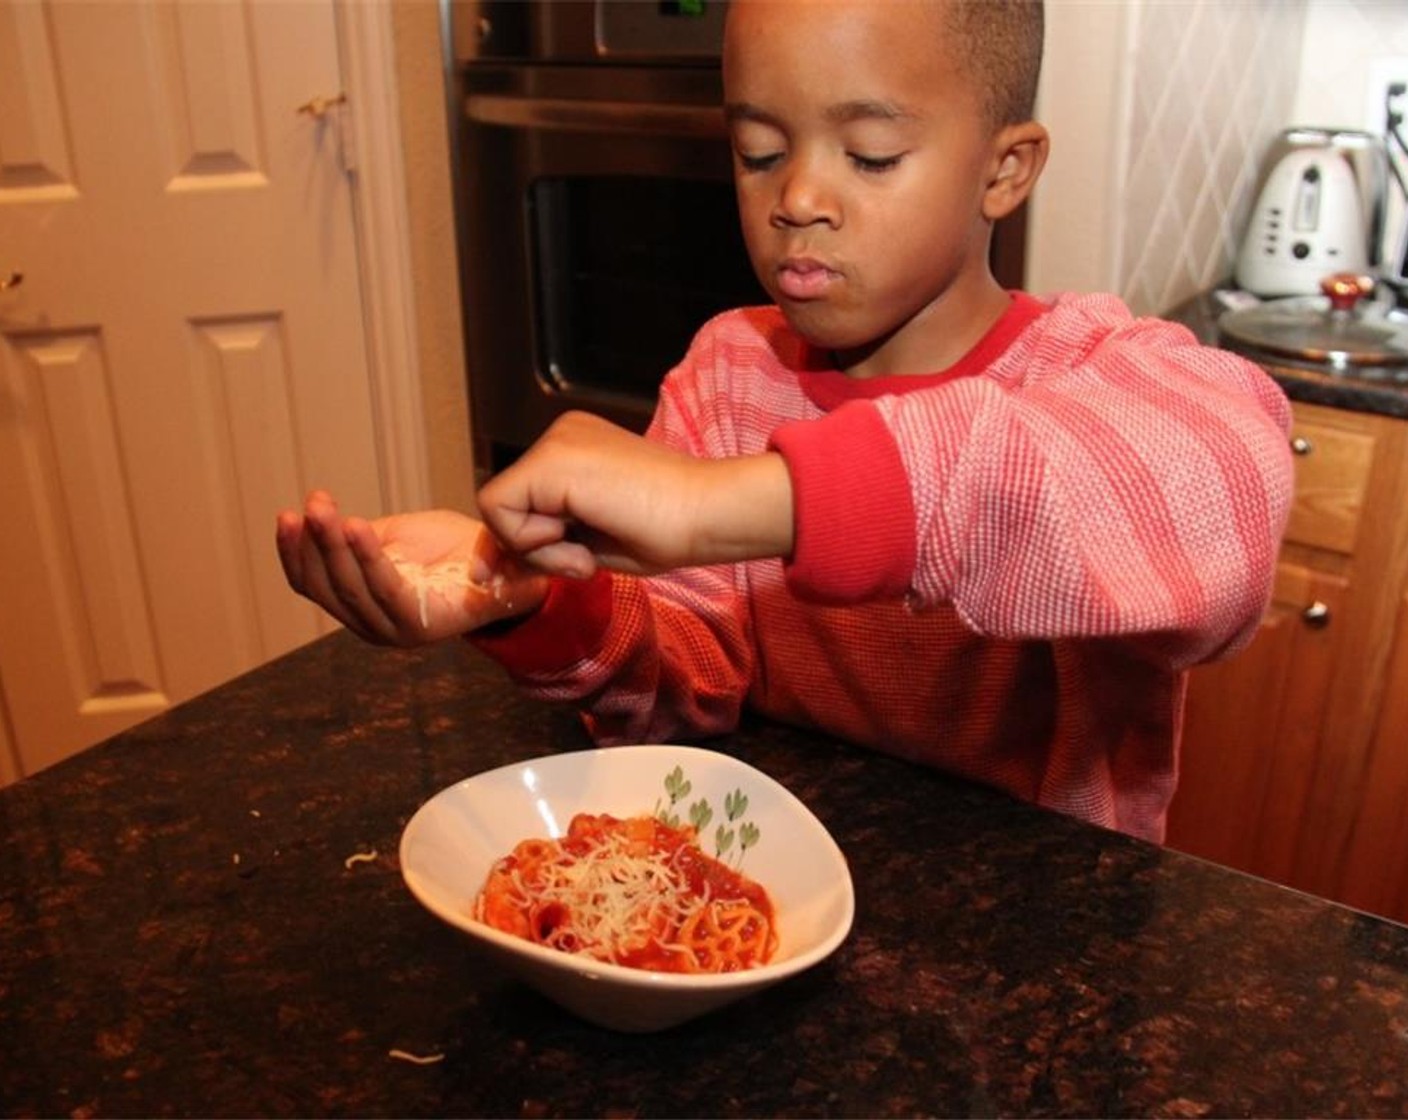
[773,297,1293,668]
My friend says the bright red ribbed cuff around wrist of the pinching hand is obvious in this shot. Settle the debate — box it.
[770,402,915,603]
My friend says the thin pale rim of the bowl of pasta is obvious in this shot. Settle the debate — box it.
[398,742,856,992]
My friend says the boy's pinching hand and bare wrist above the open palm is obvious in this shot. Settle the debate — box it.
[479,413,793,578]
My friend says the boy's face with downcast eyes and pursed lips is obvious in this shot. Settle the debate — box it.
[724,0,1005,376]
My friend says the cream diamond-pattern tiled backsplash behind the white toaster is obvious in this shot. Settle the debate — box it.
[1117,0,1408,314]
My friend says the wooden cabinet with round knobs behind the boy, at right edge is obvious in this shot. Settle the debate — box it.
[1169,404,1408,920]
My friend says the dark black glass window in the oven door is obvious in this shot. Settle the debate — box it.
[528,176,767,402]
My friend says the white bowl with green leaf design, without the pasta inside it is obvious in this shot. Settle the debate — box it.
[401,747,855,1031]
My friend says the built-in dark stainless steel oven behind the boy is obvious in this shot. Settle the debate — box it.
[444,0,1021,471]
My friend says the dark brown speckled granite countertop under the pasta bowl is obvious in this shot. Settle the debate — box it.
[0,634,1408,1117]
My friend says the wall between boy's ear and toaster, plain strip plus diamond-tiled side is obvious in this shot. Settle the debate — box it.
[1029,0,1307,314]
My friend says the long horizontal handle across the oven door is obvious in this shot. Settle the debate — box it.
[465,93,728,139]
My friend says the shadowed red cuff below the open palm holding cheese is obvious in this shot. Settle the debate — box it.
[465,568,611,676]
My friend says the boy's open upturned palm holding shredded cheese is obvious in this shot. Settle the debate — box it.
[276,490,548,645]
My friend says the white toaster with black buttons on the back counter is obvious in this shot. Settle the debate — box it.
[1235,128,1388,296]
